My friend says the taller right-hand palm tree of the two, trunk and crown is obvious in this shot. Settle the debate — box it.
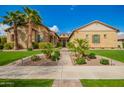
[24,7,41,48]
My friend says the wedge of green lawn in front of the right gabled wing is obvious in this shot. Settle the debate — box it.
[90,50,124,62]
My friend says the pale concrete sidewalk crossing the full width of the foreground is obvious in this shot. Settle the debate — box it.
[0,66,124,80]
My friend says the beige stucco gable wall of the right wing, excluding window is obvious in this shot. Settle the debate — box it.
[70,24,117,48]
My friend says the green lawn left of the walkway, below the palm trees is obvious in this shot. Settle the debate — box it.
[0,51,41,66]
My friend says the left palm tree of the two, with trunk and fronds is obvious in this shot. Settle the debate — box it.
[2,11,25,50]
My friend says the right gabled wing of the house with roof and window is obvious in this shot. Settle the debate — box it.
[69,21,119,48]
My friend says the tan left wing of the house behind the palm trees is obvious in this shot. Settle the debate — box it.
[5,25,58,49]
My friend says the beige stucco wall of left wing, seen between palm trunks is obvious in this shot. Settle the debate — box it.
[7,26,49,48]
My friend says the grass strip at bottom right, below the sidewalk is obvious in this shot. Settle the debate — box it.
[80,79,124,87]
